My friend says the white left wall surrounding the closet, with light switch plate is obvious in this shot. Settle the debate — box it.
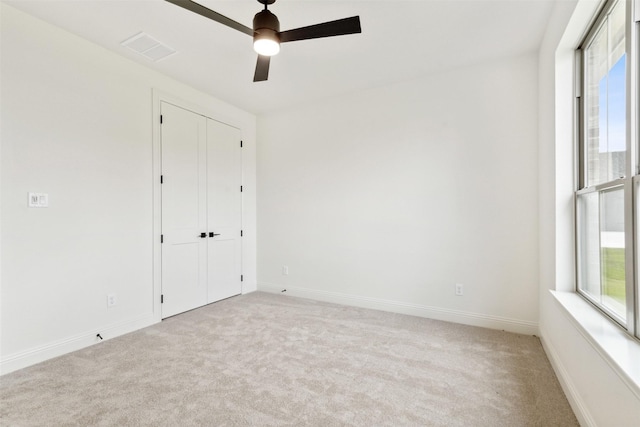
[0,4,256,372]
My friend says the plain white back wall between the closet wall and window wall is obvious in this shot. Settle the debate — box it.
[257,53,538,333]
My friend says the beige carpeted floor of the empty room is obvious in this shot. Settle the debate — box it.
[0,292,578,427]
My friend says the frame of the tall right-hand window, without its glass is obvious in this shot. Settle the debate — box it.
[573,0,640,339]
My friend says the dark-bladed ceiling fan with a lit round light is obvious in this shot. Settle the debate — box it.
[166,0,362,82]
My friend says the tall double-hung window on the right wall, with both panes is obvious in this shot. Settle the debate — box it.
[575,0,640,337]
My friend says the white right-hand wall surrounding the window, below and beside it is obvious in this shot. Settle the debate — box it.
[539,0,640,426]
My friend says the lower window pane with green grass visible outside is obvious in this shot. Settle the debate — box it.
[578,189,627,322]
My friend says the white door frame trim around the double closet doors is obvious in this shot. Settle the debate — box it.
[151,88,248,322]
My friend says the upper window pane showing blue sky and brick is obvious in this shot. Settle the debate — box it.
[585,1,626,186]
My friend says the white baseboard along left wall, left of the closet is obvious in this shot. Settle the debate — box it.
[0,313,158,375]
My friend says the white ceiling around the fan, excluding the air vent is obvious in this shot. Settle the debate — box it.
[3,0,561,114]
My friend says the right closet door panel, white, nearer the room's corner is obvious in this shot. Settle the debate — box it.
[207,119,242,302]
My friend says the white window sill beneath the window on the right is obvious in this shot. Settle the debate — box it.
[550,291,640,398]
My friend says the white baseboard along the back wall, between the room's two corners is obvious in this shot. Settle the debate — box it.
[258,283,538,335]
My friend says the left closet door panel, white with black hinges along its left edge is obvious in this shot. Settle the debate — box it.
[160,102,209,318]
